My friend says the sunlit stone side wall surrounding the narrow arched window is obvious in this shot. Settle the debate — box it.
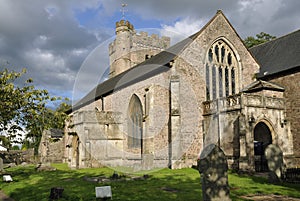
[104,69,169,167]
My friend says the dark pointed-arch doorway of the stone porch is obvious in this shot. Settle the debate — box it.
[254,122,272,172]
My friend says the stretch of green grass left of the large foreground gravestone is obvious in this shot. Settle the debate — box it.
[1,167,201,201]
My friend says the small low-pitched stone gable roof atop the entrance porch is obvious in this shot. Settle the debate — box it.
[242,80,284,93]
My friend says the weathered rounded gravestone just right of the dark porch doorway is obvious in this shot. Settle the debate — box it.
[265,144,283,183]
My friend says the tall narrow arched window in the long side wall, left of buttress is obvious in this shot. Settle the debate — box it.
[128,95,143,148]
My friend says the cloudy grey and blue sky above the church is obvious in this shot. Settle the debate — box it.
[0,0,300,103]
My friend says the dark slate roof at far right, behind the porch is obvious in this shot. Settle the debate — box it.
[250,30,300,78]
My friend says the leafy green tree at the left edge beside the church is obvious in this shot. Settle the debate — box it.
[0,69,68,151]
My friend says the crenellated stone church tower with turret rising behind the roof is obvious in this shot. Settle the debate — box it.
[109,19,170,78]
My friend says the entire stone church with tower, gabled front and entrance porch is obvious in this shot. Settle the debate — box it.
[64,11,300,171]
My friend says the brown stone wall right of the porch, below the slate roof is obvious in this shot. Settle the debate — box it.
[270,72,300,167]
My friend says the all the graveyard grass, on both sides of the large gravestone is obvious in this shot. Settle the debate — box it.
[0,164,300,201]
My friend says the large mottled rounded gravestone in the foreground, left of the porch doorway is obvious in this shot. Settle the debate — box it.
[198,144,231,201]
